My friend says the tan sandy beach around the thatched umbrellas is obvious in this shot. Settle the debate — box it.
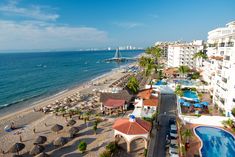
[0,63,140,157]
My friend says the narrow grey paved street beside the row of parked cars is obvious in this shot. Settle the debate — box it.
[152,94,176,157]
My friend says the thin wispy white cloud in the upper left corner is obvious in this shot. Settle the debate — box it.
[0,0,59,21]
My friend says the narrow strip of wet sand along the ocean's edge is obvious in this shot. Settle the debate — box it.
[0,62,136,126]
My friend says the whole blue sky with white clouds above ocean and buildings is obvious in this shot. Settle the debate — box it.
[0,0,235,51]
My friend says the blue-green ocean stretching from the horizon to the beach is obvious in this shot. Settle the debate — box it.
[0,50,143,115]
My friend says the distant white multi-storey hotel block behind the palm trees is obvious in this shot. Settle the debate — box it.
[167,40,203,68]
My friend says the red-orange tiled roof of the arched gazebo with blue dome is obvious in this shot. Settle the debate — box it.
[113,118,152,135]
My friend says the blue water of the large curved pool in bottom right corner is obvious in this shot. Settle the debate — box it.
[195,126,235,157]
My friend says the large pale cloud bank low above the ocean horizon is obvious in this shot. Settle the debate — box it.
[0,20,108,50]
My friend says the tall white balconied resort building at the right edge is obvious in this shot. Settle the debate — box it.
[203,21,235,117]
